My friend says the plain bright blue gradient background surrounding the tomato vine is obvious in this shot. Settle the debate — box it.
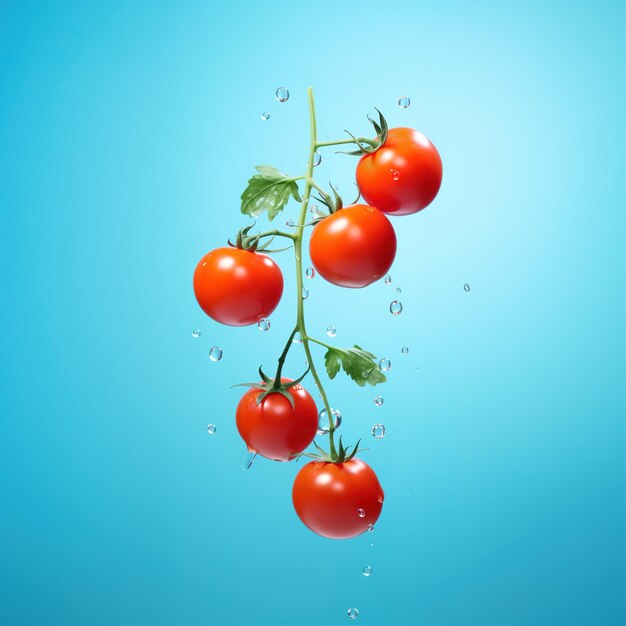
[0,0,626,626]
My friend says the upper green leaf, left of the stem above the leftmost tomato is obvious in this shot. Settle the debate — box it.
[241,165,302,221]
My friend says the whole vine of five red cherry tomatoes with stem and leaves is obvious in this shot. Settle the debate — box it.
[193,92,442,539]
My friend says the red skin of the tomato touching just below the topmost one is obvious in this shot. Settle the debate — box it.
[309,204,396,288]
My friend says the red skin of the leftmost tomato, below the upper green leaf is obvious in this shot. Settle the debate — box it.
[193,248,283,326]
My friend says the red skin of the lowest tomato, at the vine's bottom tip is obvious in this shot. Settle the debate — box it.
[292,457,385,539]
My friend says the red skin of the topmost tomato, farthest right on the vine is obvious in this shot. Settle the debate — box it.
[356,128,443,215]
